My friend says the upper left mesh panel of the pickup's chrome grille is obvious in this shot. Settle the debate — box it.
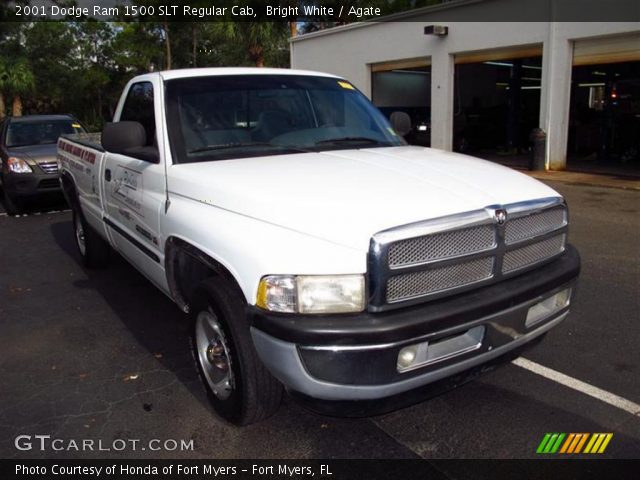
[389,225,496,268]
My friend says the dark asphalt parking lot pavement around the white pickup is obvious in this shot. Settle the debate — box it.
[0,183,640,459]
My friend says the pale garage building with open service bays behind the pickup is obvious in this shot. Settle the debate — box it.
[291,0,640,170]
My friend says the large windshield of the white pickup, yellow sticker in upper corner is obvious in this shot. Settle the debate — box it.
[166,75,405,163]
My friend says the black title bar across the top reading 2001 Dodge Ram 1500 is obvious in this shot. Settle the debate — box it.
[0,0,640,24]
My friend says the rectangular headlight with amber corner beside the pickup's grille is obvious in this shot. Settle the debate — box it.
[256,275,365,313]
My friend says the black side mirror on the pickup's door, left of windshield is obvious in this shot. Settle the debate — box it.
[102,122,160,163]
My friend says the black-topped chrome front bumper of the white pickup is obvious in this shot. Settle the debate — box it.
[249,246,580,401]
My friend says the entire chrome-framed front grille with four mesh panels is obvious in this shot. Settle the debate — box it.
[369,197,568,311]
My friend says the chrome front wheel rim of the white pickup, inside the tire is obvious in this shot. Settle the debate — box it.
[196,311,234,400]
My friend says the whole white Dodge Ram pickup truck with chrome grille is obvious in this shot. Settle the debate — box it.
[58,69,580,424]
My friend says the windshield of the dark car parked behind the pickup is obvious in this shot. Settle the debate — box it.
[6,119,85,147]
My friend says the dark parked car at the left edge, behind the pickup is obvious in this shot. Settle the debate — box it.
[0,115,85,215]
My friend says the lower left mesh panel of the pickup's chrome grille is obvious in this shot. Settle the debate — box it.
[387,257,493,302]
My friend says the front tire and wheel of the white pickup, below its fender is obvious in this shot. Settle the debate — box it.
[192,277,282,425]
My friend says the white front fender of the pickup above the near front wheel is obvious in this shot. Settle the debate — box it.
[161,197,367,305]
